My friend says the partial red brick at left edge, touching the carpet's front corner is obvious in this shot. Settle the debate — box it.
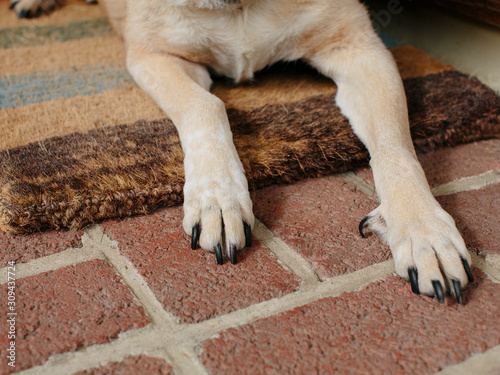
[0,230,83,267]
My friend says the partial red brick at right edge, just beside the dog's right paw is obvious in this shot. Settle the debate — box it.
[438,184,500,255]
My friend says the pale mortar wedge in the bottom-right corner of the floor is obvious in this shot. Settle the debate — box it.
[435,345,500,375]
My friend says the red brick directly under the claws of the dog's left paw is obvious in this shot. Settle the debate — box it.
[101,207,299,323]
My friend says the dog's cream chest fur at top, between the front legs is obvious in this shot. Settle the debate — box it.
[126,0,340,82]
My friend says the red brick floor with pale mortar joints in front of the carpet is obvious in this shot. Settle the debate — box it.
[0,141,500,375]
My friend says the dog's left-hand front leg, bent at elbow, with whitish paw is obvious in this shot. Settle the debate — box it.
[127,46,254,264]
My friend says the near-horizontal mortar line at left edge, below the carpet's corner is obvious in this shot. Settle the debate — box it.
[0,233,104,284]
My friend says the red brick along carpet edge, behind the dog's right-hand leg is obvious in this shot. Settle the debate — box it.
[356,139,500,187]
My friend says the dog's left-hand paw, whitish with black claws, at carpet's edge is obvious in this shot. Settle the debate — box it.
[183,160,255,264]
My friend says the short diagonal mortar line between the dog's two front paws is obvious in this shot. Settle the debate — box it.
[253,219,320,287]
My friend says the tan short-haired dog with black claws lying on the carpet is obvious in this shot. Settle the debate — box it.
[12,0,473,303]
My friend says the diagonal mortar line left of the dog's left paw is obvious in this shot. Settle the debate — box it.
[87,225,178,329]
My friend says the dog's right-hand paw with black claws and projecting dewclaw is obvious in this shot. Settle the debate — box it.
[359,202,474,303]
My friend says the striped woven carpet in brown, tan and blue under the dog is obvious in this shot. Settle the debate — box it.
[0,0,500,234]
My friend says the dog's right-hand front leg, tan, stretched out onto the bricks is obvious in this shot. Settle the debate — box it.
[309,30,473,302]
